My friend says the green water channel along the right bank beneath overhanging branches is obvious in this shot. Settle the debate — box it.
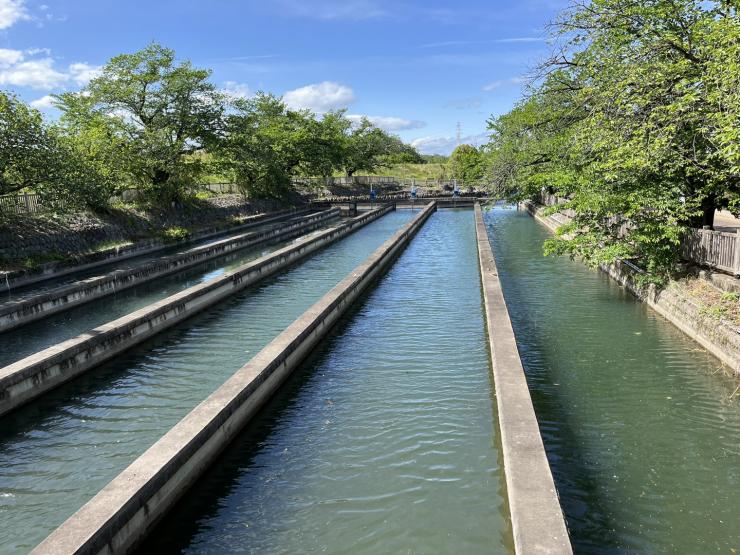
[486,208,740,554]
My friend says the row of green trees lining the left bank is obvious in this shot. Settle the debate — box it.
[0,43,422,212]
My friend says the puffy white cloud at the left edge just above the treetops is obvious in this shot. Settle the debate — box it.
[0,51,100,90]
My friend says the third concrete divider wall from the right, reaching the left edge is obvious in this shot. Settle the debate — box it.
[0,205,393,415]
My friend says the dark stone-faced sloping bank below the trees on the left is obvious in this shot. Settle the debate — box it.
[0,203,318,291]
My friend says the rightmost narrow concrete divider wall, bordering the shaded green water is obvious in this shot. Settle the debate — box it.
[475,203,573,555]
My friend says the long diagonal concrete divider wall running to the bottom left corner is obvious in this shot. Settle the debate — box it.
[34,204,436,554]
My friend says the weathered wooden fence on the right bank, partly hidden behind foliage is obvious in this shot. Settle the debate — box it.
[540,192,740,276]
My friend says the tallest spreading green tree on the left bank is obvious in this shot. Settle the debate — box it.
[58,43,224,203]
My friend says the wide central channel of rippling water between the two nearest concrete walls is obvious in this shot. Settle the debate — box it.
[142,210,510,553]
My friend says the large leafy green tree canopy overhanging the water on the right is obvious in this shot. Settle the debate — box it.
[487,0,740,277]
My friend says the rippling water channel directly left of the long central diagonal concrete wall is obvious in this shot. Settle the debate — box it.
[0,211,412,553]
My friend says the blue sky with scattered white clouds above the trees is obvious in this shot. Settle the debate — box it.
[0,0,567,153]
